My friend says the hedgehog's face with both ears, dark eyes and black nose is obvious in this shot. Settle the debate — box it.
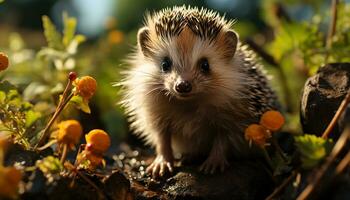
[138,7,242,100]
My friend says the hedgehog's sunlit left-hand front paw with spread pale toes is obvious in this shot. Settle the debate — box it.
[146,155,173,178]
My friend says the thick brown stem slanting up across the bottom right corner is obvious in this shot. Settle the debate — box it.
[297,126,350,200]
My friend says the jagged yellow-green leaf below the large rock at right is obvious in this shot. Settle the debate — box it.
[294,134,333,169]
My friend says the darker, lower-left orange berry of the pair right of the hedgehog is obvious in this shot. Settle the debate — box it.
[244,124,271,147]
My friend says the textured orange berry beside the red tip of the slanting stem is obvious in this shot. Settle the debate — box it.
[75,76,97,100]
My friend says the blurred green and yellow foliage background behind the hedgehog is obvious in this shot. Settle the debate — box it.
[0,0,350,145]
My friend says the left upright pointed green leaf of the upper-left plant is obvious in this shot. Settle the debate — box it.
[42,15,64,50]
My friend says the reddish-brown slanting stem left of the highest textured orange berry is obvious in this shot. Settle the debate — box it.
[35,80,74,148]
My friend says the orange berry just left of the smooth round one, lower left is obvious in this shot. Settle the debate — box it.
[57,120,83,149]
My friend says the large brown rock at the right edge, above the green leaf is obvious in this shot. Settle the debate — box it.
[300,63,350,138]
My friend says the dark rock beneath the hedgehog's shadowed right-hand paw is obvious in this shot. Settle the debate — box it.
[163,161,274,200]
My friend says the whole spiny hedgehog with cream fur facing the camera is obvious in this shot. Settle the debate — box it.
[120,6,278,177]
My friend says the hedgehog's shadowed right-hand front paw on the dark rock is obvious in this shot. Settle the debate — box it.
[199,156,229,174]
